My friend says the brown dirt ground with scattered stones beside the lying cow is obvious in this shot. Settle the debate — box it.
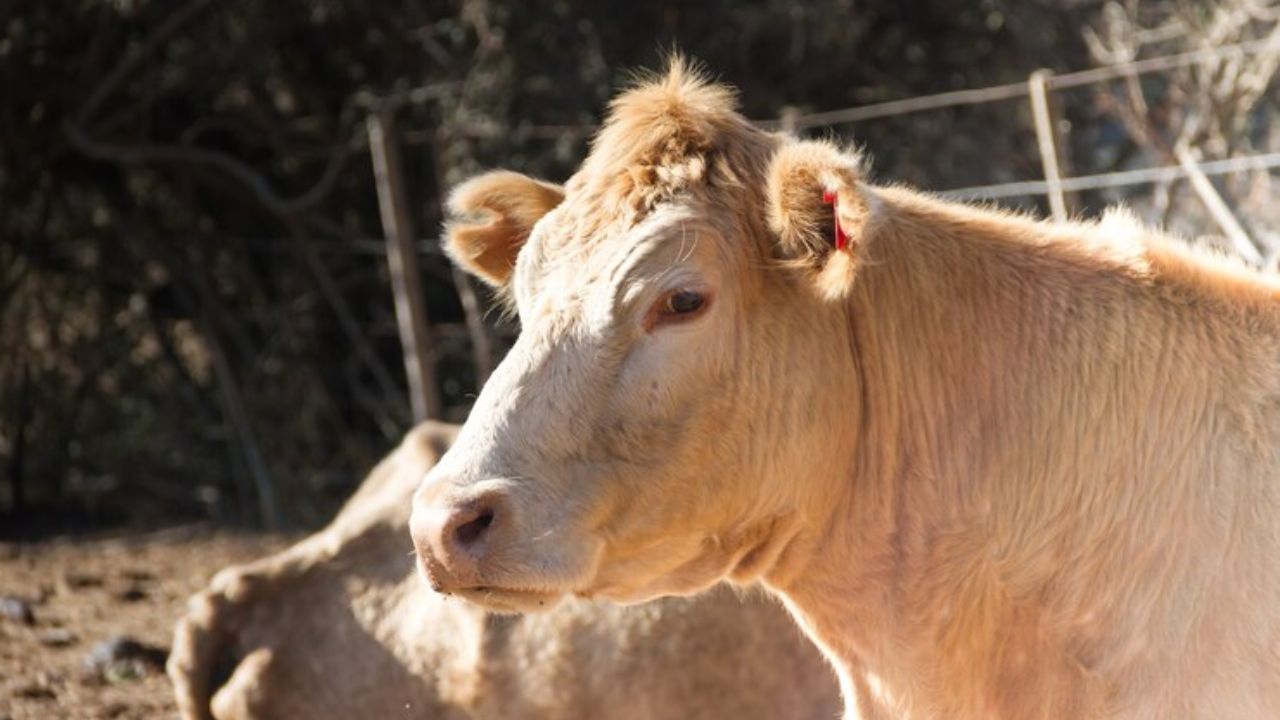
[0,529,288,720]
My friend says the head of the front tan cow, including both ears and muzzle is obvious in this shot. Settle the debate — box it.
[412,60,874,610]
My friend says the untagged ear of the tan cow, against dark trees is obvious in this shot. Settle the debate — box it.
[444,170,564,286]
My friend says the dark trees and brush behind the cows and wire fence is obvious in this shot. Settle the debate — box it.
[0,0,1280,536]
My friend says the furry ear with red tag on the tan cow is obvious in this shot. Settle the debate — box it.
[768,141,872,300]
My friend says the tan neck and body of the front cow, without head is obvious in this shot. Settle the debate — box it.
[771,191,1280,719]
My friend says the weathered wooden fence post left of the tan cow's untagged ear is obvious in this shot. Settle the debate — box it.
[366,105,442,423]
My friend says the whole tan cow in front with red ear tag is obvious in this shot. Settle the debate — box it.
[412,61,1280,720]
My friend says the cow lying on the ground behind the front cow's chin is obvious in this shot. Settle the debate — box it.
[169,424,840,720]
